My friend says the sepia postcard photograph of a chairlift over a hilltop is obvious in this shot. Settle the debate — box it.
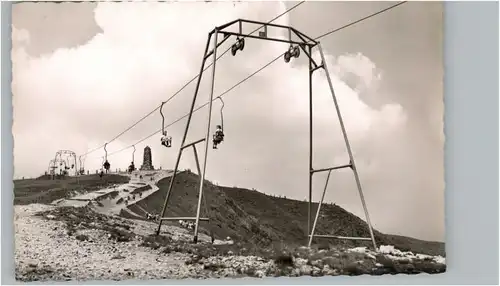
[11,1,446,282]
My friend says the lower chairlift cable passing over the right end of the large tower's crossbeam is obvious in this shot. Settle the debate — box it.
[95,1,408,159]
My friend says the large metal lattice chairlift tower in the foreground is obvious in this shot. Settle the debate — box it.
[157,19,377,249]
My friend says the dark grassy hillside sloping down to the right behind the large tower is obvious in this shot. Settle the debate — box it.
[131,172,445,256]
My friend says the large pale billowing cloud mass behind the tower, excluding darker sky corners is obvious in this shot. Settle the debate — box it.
[12,2,442,241]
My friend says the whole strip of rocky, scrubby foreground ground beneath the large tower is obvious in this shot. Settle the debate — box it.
[14,204,446,281]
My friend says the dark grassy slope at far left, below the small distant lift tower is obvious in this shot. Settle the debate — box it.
[14,174,129,205]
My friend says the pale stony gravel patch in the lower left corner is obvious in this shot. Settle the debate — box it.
[15,205,189,280]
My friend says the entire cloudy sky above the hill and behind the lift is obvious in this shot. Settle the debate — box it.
[12,1,445,241]
